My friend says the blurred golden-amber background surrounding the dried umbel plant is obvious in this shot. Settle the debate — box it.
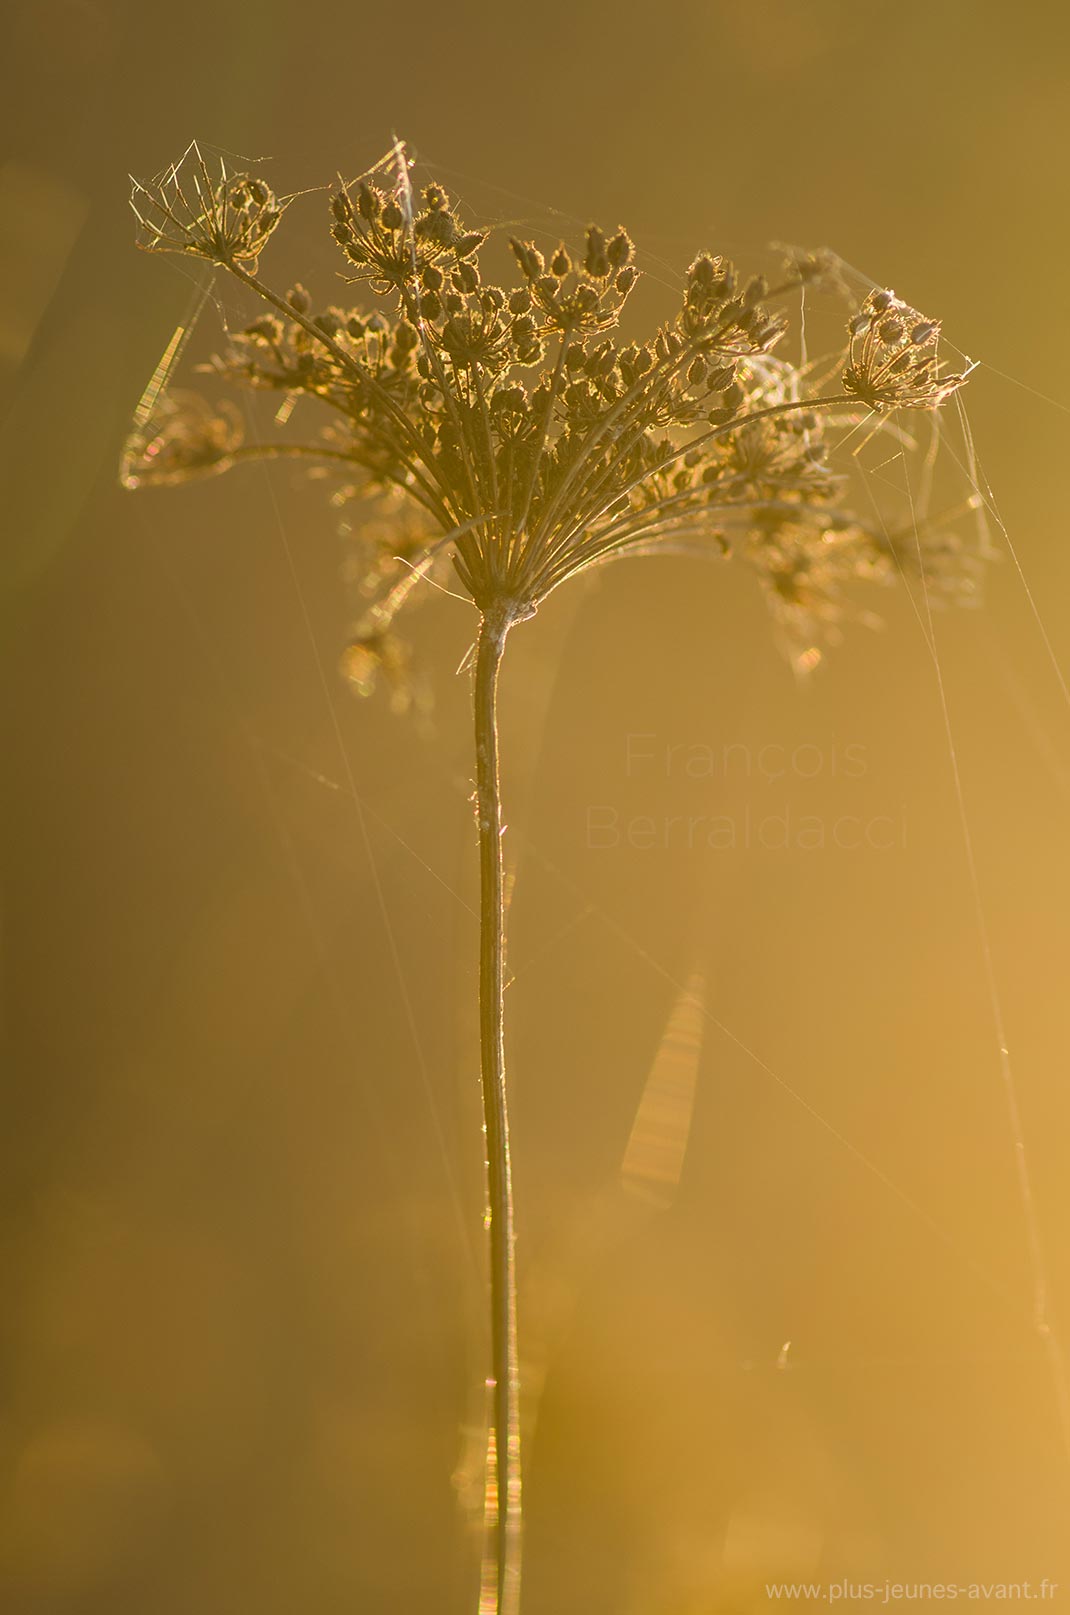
[0,0,1070,1615]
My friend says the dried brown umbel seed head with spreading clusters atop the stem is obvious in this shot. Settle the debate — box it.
[126,142,965,688]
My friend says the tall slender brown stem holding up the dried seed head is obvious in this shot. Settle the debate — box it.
[474,604,521,1615]
